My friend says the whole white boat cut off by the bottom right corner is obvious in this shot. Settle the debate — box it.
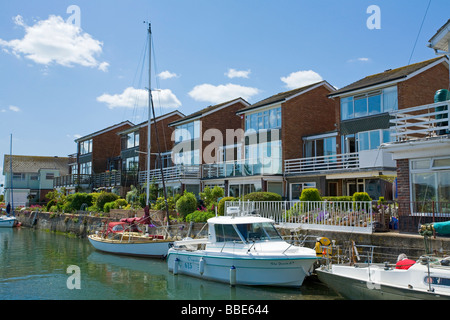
[315,256,450,300]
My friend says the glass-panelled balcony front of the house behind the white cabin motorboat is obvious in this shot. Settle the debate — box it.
[202,158,281,179]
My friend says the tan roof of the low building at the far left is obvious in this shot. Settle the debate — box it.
[3,154,71,174]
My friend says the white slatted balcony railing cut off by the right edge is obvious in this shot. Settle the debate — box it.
[390,100,450,141]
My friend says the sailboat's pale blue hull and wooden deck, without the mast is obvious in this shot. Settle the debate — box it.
[88,221,173,258]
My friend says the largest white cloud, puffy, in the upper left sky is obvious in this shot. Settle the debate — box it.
[0,15,109,71]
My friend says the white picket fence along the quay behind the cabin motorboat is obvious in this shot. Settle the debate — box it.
[224,201,375,233]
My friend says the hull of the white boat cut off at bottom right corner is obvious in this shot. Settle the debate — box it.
[315,267,450,300]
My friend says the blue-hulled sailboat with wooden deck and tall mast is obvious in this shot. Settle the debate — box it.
[88,23,173,258]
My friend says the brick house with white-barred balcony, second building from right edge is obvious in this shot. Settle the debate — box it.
[285,57,448,199]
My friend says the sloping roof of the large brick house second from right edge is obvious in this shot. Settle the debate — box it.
[328,57,448,97]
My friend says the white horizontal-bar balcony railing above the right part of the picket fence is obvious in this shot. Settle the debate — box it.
[284,152,359,175]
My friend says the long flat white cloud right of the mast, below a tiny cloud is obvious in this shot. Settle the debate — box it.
[189,83,259,103]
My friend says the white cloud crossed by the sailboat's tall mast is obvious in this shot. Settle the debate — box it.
[97,87,181,109]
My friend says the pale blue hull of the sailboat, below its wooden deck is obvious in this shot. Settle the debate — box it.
[88,236,173,258]
